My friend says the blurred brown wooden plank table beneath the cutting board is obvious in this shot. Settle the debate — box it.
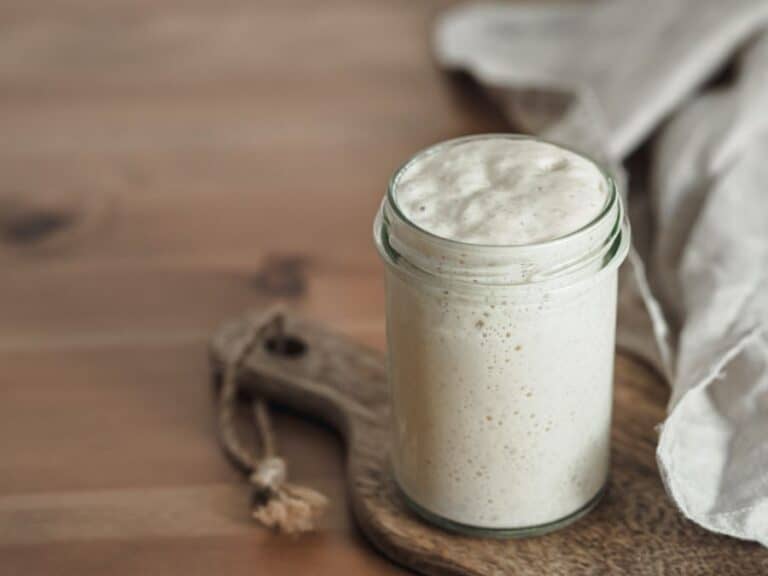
[0,0,502,576]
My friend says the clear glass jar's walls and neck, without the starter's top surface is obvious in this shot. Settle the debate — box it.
[374,135,630,537]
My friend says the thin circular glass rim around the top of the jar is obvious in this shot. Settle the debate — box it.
[386,132,618,251]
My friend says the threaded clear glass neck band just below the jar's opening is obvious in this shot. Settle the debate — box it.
[374,162,630,285]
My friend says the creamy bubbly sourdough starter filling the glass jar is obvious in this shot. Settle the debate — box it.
[377,135,627,530]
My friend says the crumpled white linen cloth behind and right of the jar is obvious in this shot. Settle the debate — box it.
[434,0,768,546]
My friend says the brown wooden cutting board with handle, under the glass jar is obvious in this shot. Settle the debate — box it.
[211,311,768,576]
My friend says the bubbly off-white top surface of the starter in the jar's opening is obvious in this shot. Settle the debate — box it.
[395,136,609,245]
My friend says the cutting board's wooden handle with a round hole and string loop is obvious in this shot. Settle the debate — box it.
[210,308,388,436]
